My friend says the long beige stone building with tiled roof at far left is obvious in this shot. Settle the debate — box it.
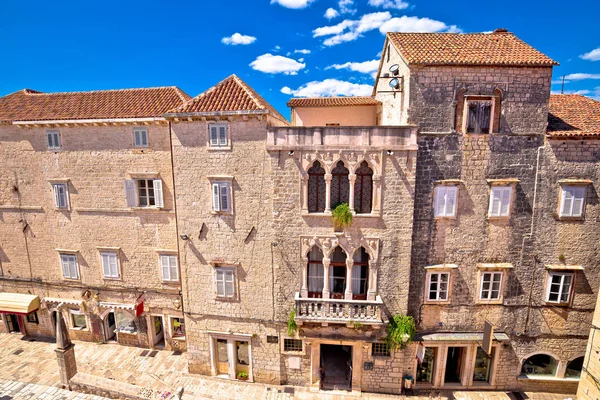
[0,87,189,348]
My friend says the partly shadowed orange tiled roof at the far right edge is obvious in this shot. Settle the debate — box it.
[547,94,600,139]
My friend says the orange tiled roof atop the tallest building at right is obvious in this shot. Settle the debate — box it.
[387,29,558,67]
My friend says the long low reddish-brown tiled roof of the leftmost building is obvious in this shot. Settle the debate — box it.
[0,86,190,121]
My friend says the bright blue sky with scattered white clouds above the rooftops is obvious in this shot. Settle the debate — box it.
[0,0,600,116]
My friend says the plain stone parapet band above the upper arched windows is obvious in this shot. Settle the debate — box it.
[267,125,417,151]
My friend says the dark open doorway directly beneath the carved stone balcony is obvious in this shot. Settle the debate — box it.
[320,344,352,390]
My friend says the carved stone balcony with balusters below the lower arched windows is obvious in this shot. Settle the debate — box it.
[296,293,385,325]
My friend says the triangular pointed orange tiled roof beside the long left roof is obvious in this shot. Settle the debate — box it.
[169,75,286,121]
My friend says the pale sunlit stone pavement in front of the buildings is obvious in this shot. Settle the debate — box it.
[0,334,574,400]
